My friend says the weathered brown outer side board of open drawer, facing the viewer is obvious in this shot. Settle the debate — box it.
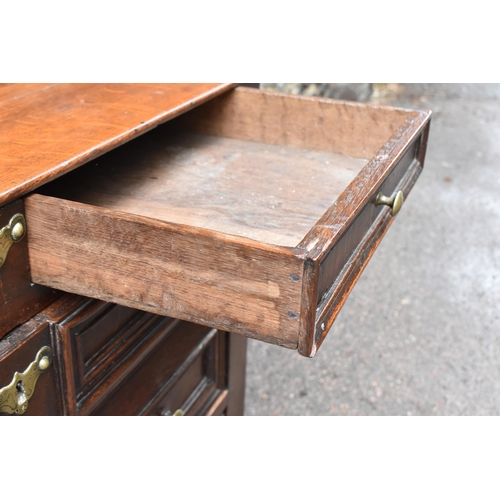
[25,194,303,348]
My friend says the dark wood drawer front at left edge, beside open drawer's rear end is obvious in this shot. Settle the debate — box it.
[0,200,60,339]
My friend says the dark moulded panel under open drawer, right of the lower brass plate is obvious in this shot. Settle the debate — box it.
[55,297,186,414]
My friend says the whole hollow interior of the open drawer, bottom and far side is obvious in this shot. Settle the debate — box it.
[34,89,406,247]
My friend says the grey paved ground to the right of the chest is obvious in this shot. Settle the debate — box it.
[245,84,500,415]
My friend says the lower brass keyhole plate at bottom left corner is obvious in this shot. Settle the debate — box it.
[0,346,52,415]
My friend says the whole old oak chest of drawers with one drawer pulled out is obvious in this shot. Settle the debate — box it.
[0,84,430,415]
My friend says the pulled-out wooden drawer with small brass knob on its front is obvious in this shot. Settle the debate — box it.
[25,88,430,356]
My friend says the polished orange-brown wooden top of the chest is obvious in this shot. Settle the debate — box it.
[0,83,234,206]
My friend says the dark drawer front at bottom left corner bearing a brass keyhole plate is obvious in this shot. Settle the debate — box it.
[0,315,62,416]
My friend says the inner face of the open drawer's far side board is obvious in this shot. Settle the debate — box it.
[179,87,419,158]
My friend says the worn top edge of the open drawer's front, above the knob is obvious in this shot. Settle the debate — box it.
[294,110,431,260]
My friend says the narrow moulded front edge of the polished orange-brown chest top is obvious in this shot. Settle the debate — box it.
[0,83,235,206]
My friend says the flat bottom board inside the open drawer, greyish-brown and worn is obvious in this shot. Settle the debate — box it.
[40,128,367,247]
